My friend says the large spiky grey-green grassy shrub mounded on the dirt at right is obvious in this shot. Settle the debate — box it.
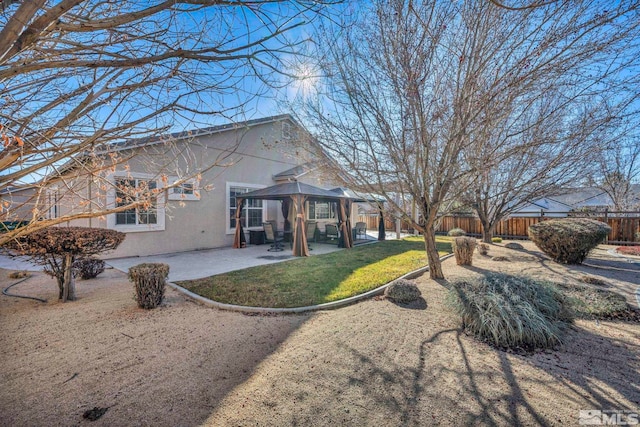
[447,273,573,350]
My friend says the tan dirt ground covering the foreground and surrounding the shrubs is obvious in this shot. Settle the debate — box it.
[0,242,640,426]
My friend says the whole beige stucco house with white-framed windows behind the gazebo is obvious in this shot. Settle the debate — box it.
[5,115,357,258]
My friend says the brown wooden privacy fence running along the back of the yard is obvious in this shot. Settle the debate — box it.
[359,211,640,245]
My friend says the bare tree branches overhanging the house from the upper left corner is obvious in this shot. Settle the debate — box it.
[0,0,332,243]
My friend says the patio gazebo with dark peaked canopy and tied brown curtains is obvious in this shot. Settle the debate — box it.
[233,181,376,256]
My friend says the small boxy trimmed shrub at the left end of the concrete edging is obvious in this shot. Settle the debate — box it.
[129,263,169,309]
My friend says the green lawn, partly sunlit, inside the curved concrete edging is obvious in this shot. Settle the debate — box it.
[178,237,451,307]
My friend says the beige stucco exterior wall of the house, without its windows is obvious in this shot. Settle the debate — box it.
[25,118,357,259]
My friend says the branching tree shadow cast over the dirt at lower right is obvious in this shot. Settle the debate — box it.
[336,322,640,426]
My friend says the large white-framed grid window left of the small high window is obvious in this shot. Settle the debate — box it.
[107,176,164,231]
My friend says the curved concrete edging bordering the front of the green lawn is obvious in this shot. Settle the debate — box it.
[167,254,453,314]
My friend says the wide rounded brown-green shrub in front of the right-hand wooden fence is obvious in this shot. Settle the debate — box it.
[529,218,611,264]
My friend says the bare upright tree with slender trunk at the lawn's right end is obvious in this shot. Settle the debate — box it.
[302,0,638,278]
